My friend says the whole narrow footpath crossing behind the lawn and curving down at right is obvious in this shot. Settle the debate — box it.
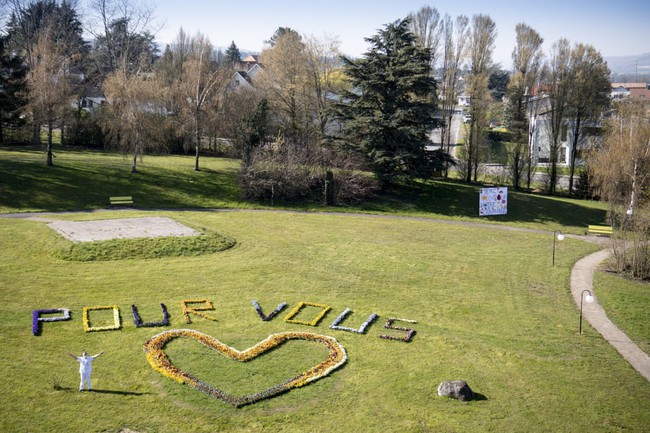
[0,209,650,381]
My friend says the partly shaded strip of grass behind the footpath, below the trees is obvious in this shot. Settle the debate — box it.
[0,147,606,234]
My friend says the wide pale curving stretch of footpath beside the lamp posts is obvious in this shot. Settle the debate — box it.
[571,249,650,381]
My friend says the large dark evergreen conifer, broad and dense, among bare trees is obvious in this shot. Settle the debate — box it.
[338,18,436,186]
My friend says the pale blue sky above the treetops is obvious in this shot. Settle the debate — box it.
[150,0,650,69]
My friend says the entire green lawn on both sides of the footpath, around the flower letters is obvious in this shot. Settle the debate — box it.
[0,144,650,432]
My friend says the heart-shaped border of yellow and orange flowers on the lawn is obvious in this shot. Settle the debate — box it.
[144,329,347,407]
